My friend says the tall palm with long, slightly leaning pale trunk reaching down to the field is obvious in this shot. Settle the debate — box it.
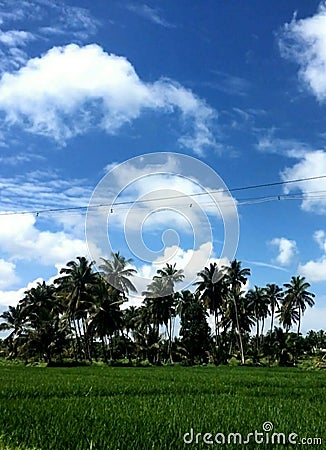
[224,259,250,364]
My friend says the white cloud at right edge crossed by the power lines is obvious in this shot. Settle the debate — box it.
[281,150,326,214]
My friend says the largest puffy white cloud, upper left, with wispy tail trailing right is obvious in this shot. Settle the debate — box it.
[0,44,217,154]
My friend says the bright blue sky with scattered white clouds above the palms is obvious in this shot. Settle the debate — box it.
[0,0,326,332]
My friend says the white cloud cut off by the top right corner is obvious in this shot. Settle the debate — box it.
[280,1,326,101]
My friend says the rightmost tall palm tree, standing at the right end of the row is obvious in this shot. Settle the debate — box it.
[284,276,315,335]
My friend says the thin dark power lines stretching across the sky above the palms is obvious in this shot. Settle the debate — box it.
[0,175,326,216]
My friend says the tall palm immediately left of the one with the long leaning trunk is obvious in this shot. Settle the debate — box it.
[194,262,226,344]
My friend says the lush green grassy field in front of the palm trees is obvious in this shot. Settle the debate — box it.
[0,366,326,450]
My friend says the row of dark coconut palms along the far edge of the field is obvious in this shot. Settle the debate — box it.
[0,253,326,365]
